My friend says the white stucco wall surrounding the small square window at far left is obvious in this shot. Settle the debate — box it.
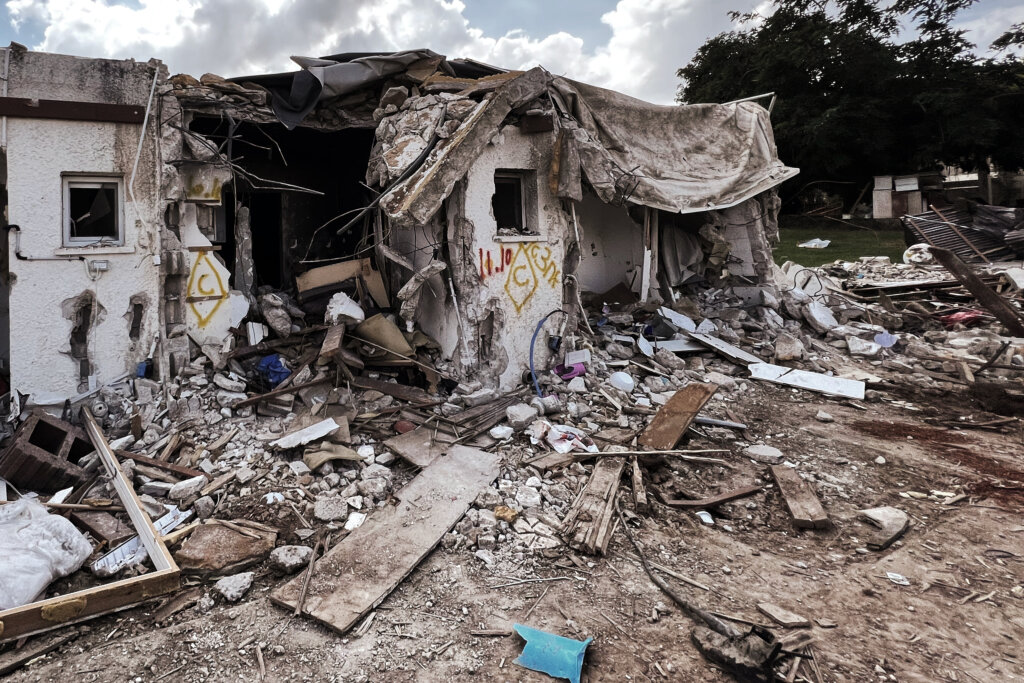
[7,52,164,402]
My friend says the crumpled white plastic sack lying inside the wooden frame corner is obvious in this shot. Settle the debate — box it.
[0,498,92,610]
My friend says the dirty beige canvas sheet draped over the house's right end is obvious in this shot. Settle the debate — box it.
[549,78,798,213]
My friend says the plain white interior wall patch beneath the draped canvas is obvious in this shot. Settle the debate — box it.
[577,194,643,293]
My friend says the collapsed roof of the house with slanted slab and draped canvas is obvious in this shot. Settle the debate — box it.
[179,49,798,222]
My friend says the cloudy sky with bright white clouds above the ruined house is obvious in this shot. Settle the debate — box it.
[0,0,1024,103]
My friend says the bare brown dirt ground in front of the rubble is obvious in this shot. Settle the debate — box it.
[7,384,1024,683]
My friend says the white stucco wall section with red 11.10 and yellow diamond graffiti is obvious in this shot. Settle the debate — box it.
[457,126,571,390]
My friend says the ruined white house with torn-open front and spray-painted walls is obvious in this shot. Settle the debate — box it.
[2,45,797,405]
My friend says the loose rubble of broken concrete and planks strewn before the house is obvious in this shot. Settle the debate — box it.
[0,250,1024,683]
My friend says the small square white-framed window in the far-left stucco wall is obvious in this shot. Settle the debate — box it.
[63,176,124,247]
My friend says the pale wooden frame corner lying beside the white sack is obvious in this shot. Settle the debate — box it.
[0,408,181,642]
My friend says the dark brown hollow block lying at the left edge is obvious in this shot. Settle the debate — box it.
[0,411,95,494]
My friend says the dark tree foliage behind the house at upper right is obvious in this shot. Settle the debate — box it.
[678,0,1024,196]
